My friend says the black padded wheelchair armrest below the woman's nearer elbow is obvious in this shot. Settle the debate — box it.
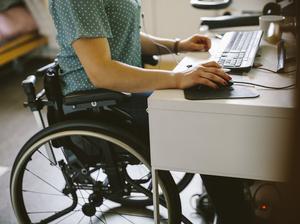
[63,89,129,106]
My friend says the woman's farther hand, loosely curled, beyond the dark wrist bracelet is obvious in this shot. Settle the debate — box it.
[178,34,211,52]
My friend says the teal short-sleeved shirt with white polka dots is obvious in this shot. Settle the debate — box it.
[49,0,141,95]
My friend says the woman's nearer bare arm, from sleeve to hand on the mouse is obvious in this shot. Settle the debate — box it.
[72,38,230,93]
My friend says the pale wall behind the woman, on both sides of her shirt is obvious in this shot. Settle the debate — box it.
[25,0,270,55]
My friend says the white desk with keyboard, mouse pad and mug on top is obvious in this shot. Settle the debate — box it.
[148,37,294,223]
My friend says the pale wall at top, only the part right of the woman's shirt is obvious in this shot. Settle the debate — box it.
[142,0,272,38]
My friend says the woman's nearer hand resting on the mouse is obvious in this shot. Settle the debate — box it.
[175,62,231,89]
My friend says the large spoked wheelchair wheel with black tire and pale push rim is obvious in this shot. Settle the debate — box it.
[10,121,181,224]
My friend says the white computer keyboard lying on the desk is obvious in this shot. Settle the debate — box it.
[215,30,263,72]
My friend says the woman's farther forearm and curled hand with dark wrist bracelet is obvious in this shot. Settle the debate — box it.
[141,33,211,55]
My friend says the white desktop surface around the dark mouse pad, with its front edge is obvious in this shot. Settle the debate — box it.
[149,40,295,117]
